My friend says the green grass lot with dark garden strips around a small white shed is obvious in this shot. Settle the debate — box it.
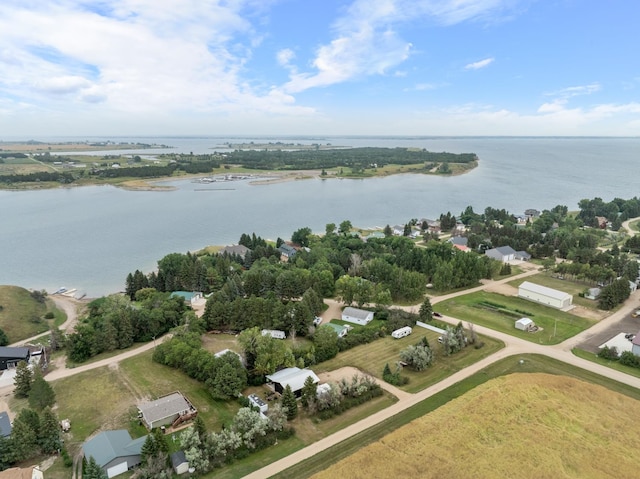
[437,291,595,344]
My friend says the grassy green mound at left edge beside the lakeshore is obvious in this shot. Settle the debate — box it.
[0,286,64,343]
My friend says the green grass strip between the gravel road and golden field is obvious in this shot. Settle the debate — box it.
[273,355,640,479]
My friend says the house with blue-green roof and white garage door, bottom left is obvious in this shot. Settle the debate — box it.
[82,429,147,478]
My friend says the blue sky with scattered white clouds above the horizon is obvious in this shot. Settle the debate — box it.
[0,0,640,140]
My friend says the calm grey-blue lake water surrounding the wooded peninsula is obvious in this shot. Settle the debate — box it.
[0,137,640,297]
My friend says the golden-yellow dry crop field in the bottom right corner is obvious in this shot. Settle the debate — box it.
[313,373,640,479]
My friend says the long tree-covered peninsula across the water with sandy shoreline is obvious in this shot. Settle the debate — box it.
[0,141,479,189]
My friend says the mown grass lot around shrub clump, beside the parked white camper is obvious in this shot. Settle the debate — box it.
[313,327,504,393]
